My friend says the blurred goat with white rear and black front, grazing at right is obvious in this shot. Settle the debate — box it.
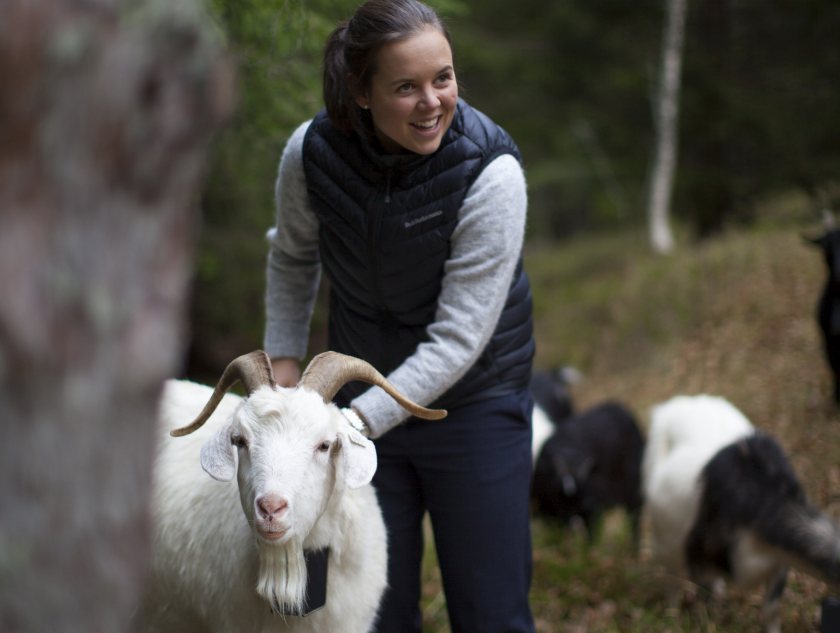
[643,395,840,633]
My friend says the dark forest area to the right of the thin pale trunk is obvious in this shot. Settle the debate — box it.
[677,0,840,236]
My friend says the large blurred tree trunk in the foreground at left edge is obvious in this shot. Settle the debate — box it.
[0,0,233,633]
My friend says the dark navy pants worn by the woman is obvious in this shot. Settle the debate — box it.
[374,391,534,633]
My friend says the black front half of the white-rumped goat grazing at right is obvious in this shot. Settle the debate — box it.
[685,432,840,631]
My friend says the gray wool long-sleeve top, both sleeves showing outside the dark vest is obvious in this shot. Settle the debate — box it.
[264,122,527,437]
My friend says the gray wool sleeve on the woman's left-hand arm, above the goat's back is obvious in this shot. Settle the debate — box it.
[263,121,321,359]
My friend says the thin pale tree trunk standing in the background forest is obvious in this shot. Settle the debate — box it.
[648,0,688,253]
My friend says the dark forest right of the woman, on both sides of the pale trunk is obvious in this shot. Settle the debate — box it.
[453,0,840,238]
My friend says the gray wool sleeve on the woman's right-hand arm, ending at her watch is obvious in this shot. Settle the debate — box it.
[352,155,527,437]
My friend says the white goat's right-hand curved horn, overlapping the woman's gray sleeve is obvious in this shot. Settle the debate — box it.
[298,352,446,420]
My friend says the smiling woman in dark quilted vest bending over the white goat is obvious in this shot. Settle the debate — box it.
[265,0,534,633]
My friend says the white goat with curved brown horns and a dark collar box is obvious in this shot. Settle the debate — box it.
[141,351,446,633]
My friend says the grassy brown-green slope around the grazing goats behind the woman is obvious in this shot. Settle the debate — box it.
[423,225,840,633]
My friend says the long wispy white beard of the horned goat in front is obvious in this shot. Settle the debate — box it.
[257,538,307,615]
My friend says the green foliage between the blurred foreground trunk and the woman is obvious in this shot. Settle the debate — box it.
[188,0,356,379]
